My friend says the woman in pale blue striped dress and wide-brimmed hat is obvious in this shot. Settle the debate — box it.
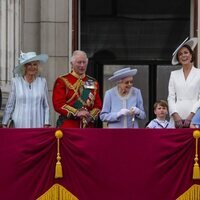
[2,52,50,128]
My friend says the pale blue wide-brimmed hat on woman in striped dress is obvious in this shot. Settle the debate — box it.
[13,52,48,74]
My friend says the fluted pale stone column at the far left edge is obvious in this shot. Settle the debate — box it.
[0,0,21,89]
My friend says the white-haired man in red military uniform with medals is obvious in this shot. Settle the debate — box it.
[52,50,102,128]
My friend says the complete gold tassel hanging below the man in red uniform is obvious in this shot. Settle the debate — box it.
[55,130,63,178]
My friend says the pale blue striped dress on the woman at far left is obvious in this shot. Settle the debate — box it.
[2,77,50,128]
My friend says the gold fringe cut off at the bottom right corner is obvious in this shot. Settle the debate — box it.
[176,184,200,200]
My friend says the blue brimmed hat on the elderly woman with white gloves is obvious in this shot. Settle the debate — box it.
[108,67,137,81]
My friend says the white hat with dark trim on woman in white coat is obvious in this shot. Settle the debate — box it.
[172,37,198,65]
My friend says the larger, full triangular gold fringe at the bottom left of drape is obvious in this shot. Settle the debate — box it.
[37,184,78,200]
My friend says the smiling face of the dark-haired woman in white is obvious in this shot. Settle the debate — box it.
[178,47,192,65]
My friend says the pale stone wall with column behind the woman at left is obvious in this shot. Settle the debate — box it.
[0,0,71,126]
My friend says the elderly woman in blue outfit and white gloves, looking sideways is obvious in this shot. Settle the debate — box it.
[100,67,146,128]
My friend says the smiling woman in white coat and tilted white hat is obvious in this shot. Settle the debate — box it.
[168,38,200,128]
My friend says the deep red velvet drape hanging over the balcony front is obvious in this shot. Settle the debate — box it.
[0,128,200,200]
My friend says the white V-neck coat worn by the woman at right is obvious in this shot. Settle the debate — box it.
[168,66,200,126]
